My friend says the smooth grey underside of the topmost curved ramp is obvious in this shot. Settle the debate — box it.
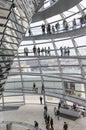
[32,0,81,22]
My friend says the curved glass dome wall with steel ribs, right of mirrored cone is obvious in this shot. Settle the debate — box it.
[2,0,86,105]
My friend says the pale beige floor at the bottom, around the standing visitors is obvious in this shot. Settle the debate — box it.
[0,104,86,130]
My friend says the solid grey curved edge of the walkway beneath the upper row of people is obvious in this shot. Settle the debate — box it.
[23,26,86,41]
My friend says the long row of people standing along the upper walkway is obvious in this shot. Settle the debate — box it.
[28,15,86,36]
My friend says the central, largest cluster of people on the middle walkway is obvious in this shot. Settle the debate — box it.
[33,45,50,56]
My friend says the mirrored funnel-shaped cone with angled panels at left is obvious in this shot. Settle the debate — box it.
[0,0,40,106]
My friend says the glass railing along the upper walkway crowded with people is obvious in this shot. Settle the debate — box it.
[26,18,86,36]
